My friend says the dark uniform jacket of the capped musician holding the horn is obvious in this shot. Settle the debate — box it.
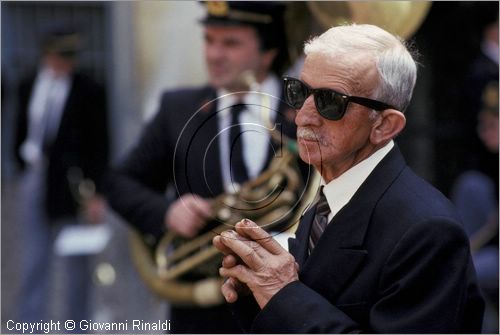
[108,87,296,242]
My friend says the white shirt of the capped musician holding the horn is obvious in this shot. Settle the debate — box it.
[217,75,281,192]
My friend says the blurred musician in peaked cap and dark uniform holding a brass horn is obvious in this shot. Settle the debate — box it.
[108,1,295,333]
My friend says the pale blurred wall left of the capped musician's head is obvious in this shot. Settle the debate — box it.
[108,1,206,159]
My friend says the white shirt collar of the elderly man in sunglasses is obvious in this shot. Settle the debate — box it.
[321,140,394,219]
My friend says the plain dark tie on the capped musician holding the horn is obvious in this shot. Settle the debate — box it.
[229,104,248,184]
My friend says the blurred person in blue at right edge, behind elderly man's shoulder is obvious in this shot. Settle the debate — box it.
[451,81,499,333]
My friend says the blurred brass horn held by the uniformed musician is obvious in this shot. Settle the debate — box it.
[131,133,319,306]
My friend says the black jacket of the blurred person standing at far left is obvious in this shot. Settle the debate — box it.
[15,74,109,219]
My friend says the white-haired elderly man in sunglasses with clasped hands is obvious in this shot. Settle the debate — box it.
[213,25,483,333]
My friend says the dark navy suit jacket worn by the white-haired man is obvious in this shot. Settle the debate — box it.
[235,147,483,333]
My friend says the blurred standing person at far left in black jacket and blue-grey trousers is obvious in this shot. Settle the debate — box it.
[14,24,108,328]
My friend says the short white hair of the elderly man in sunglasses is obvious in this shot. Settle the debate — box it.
[304,24,417,111]
